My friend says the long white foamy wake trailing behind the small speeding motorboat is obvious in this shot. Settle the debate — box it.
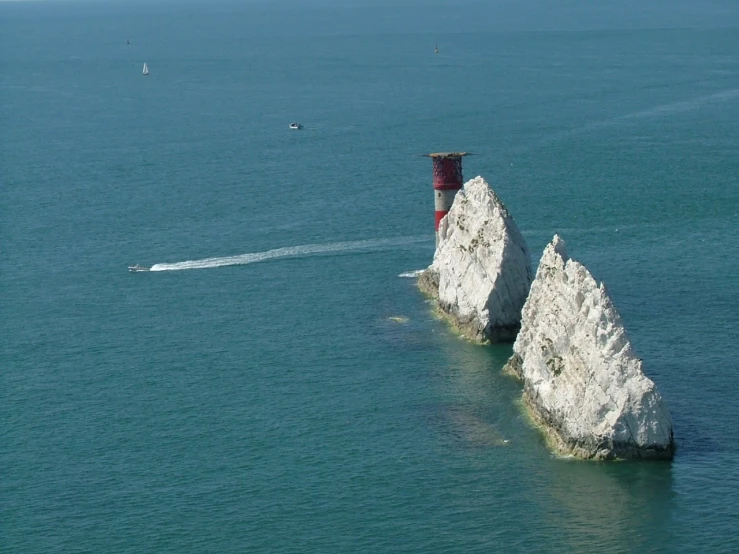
[149,236,432,271]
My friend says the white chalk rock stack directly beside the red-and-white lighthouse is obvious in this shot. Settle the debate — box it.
[419,177,533,342]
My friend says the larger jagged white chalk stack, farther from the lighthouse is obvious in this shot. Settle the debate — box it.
[506,235,675,459]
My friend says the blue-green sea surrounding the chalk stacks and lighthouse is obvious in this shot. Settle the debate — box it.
[0,0,739,553]
